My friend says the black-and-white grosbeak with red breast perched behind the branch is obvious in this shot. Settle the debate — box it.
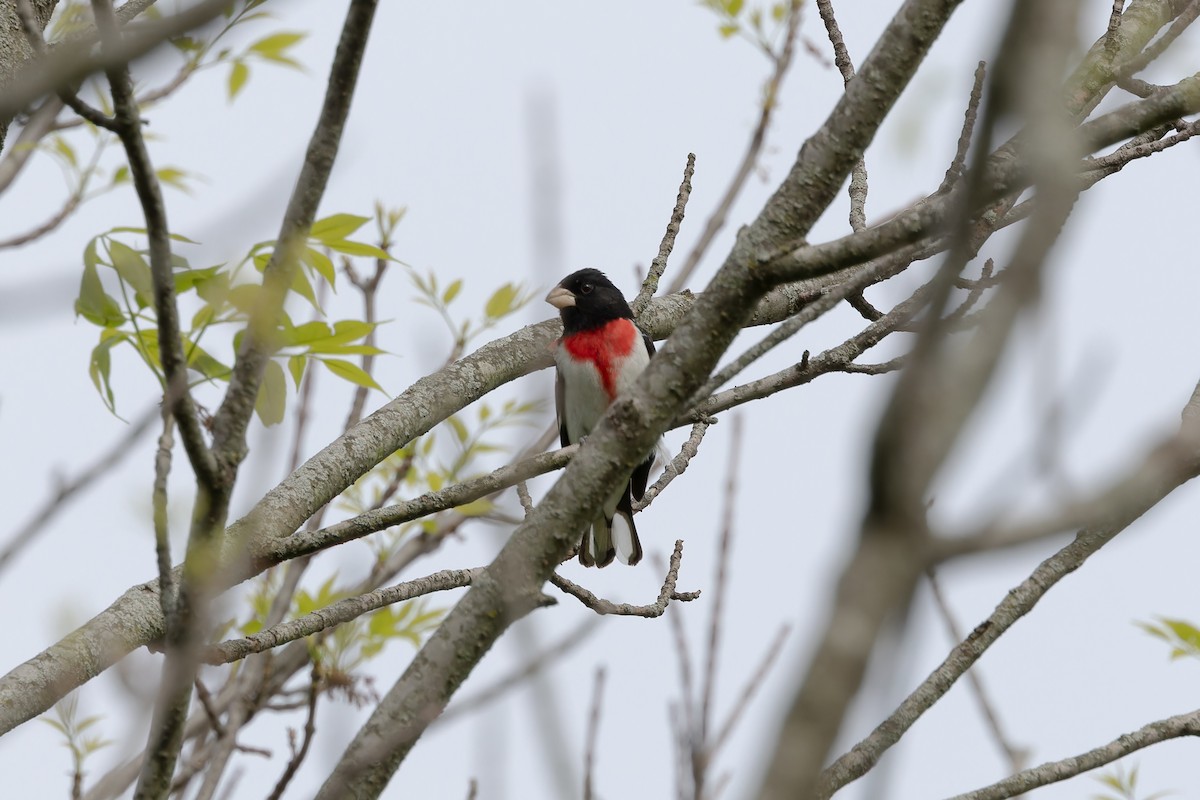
[546,269,654,566]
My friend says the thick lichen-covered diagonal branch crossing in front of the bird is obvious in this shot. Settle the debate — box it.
[317,0,958,800]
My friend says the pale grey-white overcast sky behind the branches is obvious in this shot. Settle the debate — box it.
[0,0,1200,800]
